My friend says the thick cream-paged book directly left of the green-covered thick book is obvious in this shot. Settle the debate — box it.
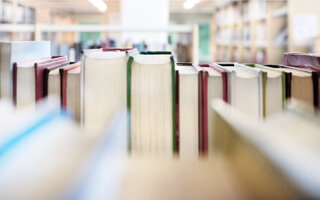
[80,49,136,137]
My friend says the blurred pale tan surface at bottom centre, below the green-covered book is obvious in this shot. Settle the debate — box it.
[117,158,248,200]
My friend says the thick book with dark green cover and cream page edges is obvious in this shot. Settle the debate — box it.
[127,52,176,156]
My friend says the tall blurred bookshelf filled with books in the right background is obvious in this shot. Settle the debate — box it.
[212,0,320,64]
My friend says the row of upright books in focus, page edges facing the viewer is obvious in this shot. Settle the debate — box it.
[1,42,319,158]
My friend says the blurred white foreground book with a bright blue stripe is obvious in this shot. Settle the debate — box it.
[0,101,91,199]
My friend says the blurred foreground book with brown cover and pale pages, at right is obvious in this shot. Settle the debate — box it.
[212,100,320,199]
